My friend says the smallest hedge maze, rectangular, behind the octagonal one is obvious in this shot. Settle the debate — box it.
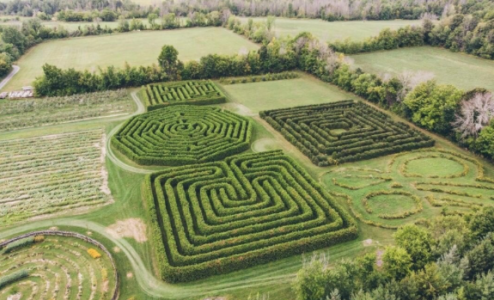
[142,80,226,111]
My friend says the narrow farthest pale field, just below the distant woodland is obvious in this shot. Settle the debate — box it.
[241,18,421,42]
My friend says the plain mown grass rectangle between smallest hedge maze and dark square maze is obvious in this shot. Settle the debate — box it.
[222,75,357,112]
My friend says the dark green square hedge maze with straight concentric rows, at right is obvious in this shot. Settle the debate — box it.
[260,100,434,166]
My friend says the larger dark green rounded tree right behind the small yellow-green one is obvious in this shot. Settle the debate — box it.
[394,225,432,270]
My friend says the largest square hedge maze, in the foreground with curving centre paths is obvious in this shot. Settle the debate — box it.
[143,151,357,282]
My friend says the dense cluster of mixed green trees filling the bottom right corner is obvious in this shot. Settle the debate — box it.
[294,207,494,300]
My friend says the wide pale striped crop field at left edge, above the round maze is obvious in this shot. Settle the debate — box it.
[0,130,111,224]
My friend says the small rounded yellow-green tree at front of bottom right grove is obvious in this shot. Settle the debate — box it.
[382,246,412,280]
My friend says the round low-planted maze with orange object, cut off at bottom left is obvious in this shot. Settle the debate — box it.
[0,232,118,300]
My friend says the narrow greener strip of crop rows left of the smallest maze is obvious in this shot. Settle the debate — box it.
[0,90,133,131]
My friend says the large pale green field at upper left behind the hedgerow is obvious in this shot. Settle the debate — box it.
[4,27,258,91]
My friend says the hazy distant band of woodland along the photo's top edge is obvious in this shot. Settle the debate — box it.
[0,0,494,21]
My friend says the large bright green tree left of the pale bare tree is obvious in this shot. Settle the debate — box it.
[403,81,463,135]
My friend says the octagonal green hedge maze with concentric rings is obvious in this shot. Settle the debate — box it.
[112,105,252,166]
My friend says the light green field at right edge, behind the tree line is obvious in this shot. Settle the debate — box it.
[352,47,494,91]
